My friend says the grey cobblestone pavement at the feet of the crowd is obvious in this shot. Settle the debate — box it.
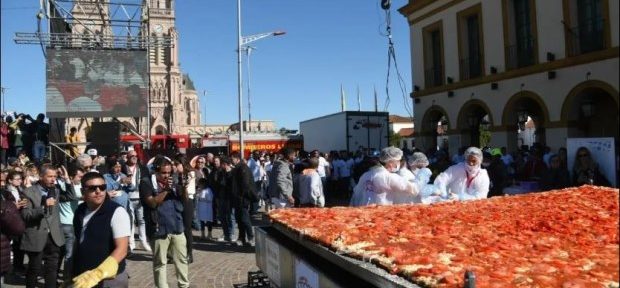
[1,214,268,288]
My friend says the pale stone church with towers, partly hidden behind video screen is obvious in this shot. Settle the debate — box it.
[64,0,200,147]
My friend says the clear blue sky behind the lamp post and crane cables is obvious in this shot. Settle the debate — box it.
[1,0,411,129]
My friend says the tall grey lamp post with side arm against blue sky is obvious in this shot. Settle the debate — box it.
[237,0,286,159]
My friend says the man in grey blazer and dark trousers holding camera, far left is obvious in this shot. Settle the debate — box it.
[21,164,65,287]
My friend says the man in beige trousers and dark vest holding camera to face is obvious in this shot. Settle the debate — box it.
[139,156,189,288]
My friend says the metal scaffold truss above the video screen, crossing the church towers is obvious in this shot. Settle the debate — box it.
[14,0,174,49]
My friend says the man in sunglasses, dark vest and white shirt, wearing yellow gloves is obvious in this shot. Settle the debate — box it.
[73,172,131,288]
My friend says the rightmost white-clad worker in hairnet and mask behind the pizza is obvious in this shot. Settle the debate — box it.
[434,147,490,201]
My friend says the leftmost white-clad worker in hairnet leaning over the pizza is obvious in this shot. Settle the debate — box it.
[350,146,419,206]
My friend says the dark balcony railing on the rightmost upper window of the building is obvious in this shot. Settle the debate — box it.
[566,18,607,56]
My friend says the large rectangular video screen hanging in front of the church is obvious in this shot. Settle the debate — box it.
[46,48,148,118]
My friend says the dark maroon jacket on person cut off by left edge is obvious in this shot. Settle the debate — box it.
[0,198,25,275]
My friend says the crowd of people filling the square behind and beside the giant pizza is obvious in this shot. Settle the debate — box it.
[0,117,609,287]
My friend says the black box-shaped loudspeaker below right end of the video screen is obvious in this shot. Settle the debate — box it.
[90,122,121,156]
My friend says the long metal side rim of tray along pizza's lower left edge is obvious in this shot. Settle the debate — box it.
[272,222,420,288]
